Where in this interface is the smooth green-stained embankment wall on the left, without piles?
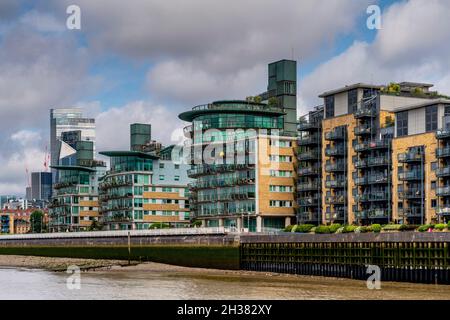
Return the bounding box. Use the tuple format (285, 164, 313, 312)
(0, 235, 239, 270)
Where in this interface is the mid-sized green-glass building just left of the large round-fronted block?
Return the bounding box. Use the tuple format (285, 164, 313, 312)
(100, 124, 190, 230)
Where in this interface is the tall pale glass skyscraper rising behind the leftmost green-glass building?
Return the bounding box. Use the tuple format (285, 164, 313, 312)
(50, 108, 95, 182)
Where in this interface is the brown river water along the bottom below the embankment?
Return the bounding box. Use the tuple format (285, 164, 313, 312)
(0, 268, 450, 300)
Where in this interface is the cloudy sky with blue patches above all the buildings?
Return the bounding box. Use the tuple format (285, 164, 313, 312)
(0, 0, 450, 195)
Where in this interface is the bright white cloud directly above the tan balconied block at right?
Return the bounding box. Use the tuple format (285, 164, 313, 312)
(300, 0, 450, 112)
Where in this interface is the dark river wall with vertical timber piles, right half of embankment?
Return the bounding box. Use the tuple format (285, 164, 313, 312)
(240, 232, 450, 284)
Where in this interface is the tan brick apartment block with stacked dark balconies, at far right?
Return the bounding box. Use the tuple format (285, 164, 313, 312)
(298, 82, 450, 224)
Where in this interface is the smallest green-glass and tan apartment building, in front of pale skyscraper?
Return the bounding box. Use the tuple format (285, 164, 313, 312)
(49, 141, 106, 232)
